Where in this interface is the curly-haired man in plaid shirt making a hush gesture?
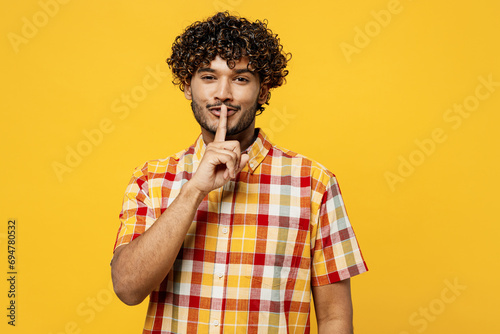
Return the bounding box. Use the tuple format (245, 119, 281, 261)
(112, 12, 367, 333)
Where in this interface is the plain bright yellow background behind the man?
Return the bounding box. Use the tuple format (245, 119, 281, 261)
(0, 0, 500, 334)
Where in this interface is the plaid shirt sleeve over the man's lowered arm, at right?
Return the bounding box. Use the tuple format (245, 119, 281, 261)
(311, 176, 368, 286)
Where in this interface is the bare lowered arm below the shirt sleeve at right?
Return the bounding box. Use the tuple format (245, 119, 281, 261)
(312, 279, 353, 334)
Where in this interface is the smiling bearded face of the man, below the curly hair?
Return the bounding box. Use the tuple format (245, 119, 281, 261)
(184, 56, 268, 137)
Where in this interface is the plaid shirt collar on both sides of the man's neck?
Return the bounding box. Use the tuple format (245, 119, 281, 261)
(194, 128, 273, 174)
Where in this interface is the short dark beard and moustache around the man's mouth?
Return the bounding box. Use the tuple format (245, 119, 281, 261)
(191, 99, 258, 136)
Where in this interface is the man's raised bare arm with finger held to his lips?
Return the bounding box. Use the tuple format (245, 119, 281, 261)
(111, 106, 248, 305)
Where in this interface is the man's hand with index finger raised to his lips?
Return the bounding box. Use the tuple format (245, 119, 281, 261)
(190, 104, 249, 194)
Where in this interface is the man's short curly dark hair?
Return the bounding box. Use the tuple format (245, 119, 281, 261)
(167, 11, 292, 114)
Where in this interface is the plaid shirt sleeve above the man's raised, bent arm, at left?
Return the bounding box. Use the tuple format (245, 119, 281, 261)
(113, 163, 155, 252)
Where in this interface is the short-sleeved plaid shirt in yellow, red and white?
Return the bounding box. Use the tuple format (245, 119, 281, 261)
(115, 130, 367, 333)
